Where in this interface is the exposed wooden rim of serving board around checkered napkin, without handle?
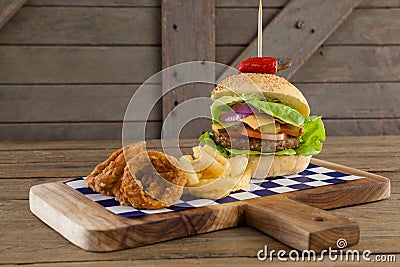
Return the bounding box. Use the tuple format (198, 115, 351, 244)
(29, 159, 390, 251)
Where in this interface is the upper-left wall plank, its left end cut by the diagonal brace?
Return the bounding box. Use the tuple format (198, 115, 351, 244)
(0, 6, 161, 46)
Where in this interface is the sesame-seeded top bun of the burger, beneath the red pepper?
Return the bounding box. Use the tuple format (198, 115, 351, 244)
(211, 73, 310, 116)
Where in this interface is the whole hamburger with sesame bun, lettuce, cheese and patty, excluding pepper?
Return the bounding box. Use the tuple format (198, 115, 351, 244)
(199, 73, 325, 179)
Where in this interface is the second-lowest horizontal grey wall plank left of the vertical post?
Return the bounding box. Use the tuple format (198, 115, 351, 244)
(0, 84, 162, 123)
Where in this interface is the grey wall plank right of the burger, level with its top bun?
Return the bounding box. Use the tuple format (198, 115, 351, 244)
(295, 83, 400, 119)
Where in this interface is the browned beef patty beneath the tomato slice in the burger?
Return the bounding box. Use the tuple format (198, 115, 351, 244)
(213, 131, 300, 153)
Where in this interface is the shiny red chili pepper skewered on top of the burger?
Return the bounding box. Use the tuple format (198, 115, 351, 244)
(238, 57, 292, 74)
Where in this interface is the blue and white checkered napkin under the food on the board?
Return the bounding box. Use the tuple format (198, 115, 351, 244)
(65, 164, 363, 217)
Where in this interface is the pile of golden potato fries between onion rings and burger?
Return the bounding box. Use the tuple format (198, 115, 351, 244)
(179, 145, 251, 199)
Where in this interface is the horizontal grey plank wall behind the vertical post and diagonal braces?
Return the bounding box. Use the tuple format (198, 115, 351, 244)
(0, 0, 400, 140)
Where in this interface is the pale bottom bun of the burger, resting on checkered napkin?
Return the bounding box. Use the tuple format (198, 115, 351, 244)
(249, 155, 311, 179)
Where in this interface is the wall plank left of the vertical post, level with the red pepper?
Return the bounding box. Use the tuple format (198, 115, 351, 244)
(0, 46, 161, 84)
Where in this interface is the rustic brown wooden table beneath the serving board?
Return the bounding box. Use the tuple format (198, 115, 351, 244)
(0, 136, 400, 266)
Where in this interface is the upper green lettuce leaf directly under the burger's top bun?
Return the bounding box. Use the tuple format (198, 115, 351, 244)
(211, 96, 305, 126)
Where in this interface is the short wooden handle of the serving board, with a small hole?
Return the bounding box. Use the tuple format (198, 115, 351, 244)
(244, 196, 360, 252)
